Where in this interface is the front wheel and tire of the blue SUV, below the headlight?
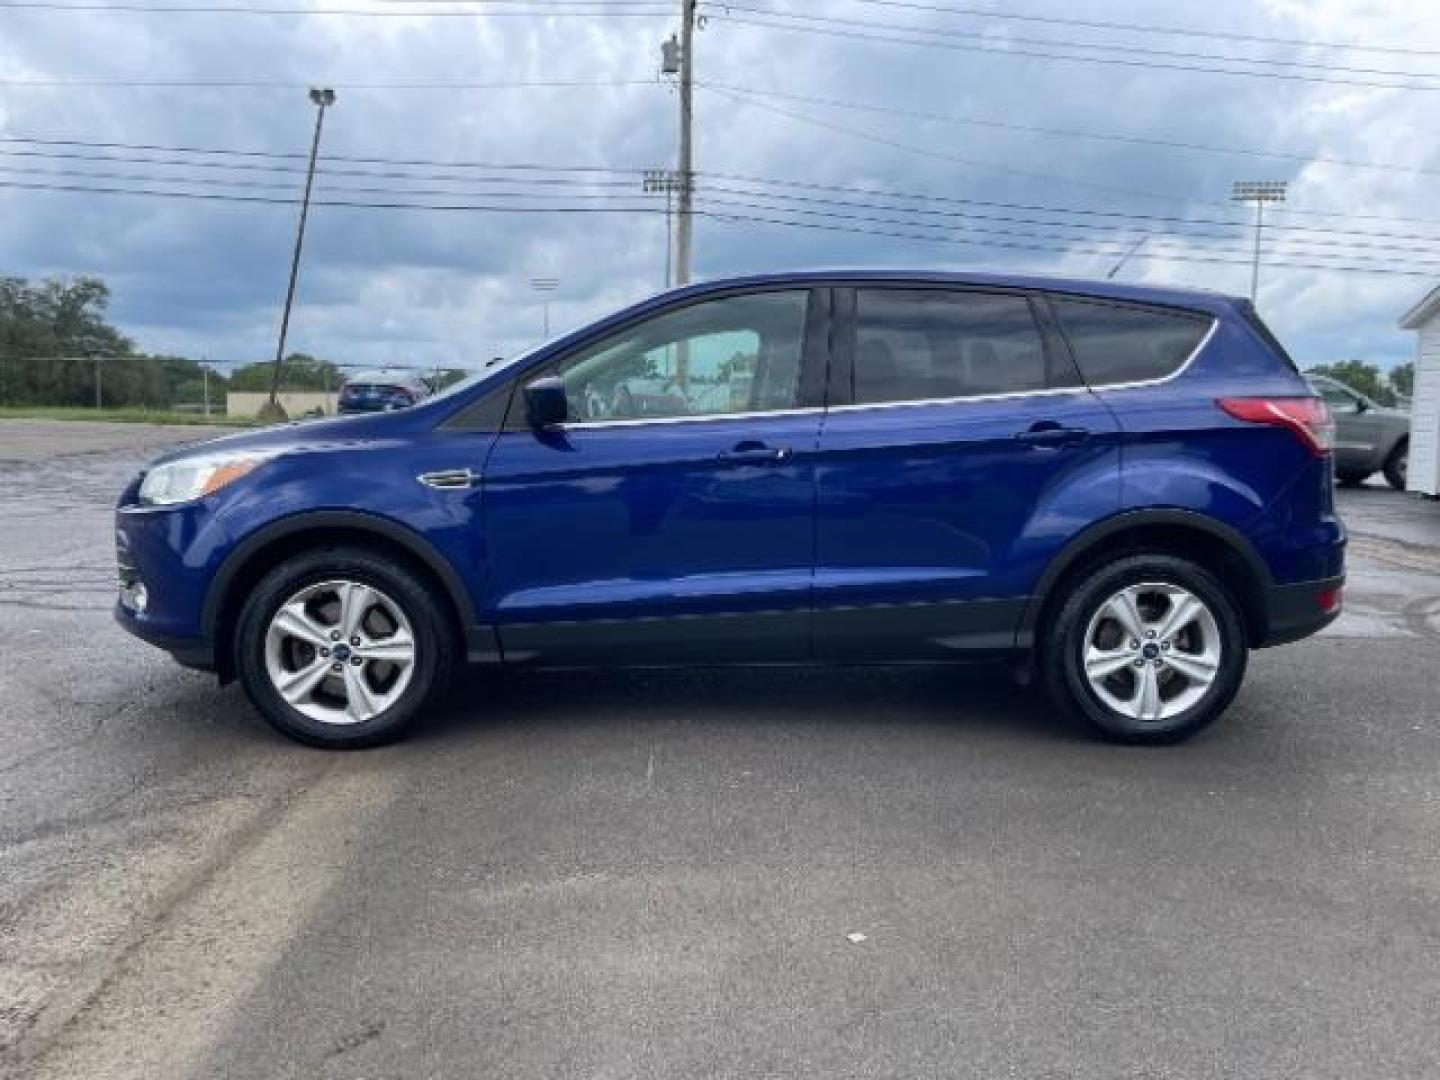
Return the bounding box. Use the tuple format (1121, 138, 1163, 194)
(235, 547, 454, 749)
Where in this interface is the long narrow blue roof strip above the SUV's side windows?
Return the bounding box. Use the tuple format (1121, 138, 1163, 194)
(662, 268, 1234, 311)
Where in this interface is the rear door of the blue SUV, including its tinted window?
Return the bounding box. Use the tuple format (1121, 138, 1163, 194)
(814, 285, 1119, 660)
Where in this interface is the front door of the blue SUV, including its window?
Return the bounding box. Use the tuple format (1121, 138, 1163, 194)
(482, 289, 828, 664)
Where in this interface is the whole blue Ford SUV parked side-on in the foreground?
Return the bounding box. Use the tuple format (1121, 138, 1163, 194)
(115, 272, 1345, 747)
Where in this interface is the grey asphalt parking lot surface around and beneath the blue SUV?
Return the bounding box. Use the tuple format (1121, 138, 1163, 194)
(0, 422, 1440, 1080)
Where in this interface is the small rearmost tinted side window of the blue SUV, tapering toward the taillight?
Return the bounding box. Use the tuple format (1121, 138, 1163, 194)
(1050, 297, 1211, 386)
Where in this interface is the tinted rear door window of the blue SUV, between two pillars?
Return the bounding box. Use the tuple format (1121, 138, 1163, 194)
(854, 289, 1074, 405)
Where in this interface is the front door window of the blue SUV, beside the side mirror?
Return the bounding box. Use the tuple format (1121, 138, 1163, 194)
(552, 289, 808, 423)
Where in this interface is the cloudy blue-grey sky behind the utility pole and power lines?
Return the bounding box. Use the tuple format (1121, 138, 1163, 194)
(0, 0, 1440, 366)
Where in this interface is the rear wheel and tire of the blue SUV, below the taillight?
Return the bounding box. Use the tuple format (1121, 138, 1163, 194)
(1041, 554, 1248, 744)
